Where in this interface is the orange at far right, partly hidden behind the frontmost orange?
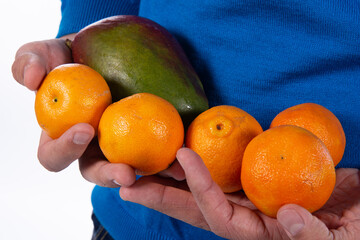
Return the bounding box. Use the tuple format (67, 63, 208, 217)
(270, 103, 346, 166)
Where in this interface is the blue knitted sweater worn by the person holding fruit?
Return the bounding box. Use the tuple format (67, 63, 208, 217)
(58, 0, 360, 239)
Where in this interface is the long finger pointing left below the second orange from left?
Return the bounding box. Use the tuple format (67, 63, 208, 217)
(120, 176, 210, 230)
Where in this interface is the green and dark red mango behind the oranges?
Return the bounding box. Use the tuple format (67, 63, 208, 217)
(71, 15, 209, 127)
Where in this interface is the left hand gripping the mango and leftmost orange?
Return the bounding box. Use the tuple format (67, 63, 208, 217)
(12, 38, 136, 187)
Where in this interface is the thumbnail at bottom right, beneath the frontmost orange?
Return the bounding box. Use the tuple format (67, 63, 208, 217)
(277, 210, 305, 236)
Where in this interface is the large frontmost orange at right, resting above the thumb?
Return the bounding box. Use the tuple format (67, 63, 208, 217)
(241, 125, 335, 217)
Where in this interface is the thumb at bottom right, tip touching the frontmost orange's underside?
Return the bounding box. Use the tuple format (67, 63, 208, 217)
(277, 204, 333, 240)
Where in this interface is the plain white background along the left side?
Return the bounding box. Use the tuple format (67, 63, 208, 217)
(0, 0, 93, 240)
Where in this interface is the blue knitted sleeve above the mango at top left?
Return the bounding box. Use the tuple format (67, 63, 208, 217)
(56, 0, 140, 37)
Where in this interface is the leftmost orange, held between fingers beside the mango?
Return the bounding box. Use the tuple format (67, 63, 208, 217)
(35, 64, 112, 139)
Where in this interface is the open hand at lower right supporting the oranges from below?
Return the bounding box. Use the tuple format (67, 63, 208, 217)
(120, 148, 360, 239)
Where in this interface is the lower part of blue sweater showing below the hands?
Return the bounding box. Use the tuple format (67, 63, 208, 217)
(92, 186, 222, 240)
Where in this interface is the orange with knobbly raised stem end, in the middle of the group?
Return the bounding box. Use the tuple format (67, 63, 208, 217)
(185, 105, 263, 193)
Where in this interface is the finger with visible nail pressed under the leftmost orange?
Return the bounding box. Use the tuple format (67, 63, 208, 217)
(38, 123, 95, 172)
